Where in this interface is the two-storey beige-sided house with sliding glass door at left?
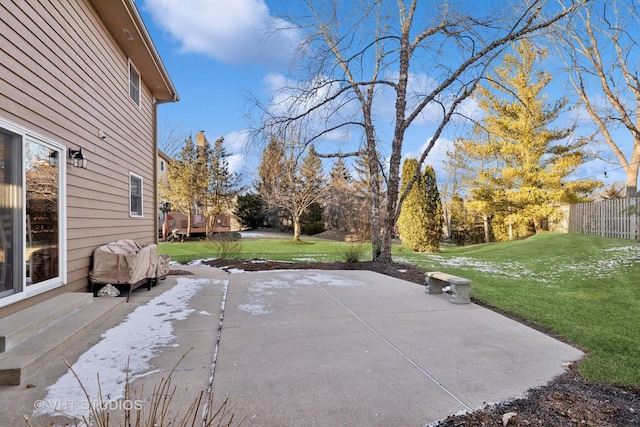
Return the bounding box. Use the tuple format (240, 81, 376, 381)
(0, 0, 178, 318)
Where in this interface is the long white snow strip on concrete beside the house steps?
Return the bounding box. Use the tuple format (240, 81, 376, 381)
(36, 277, 222, 418)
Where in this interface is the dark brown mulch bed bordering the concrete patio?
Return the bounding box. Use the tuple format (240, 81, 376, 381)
(170, 260, 640, 427)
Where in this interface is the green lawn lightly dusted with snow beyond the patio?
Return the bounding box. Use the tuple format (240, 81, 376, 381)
(160, 233, 640, 385)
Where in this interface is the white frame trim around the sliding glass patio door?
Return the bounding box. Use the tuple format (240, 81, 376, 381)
(0, 117, 67, 308)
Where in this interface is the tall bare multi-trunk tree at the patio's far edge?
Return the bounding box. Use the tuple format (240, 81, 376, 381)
(264, 0, 588, 262)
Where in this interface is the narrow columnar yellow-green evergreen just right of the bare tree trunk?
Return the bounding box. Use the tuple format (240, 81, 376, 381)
(398, 158, 444, 252)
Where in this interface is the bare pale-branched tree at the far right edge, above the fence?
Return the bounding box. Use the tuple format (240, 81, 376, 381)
(555, 0, 640, 197)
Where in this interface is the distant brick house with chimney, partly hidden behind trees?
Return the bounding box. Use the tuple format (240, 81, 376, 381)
(158, 131, 240, 238)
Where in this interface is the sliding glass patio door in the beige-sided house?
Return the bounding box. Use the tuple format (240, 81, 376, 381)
(0, 120, 65, 306)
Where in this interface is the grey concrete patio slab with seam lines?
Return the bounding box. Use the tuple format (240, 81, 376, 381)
(0, 266, 583, 426)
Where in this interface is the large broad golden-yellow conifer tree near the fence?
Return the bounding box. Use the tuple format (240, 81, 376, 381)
(457, 40, 597, 238)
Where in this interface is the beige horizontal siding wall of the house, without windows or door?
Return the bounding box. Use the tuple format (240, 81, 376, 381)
(0, 0, 156, 317)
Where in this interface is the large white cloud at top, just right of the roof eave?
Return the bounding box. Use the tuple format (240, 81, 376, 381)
(143, 0, 299, 65)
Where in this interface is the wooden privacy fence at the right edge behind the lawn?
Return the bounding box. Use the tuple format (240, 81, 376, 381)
(569, 197, 640, 240)
